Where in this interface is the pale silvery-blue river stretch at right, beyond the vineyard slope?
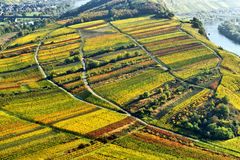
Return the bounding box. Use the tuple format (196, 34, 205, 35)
(205, 23, 240, 56)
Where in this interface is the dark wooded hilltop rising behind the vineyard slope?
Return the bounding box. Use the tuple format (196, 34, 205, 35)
(61, 0, 170, 20)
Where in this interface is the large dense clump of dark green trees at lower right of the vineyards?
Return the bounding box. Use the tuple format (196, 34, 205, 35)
(172, 96, 239, 140)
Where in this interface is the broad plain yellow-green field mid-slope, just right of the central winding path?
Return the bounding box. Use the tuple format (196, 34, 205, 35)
(94, 69, 174, 105)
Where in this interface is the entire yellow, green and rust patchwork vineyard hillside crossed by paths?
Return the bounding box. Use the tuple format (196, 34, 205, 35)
(0, 10, 240, 160)
